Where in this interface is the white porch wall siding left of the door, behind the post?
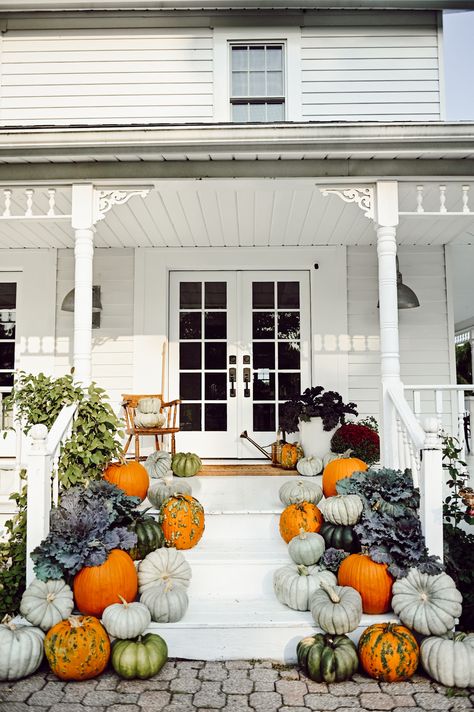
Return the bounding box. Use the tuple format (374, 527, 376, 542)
(56, 249, 134, 410)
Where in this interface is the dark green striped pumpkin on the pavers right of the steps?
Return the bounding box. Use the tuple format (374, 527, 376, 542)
(296, 633, 359, 682)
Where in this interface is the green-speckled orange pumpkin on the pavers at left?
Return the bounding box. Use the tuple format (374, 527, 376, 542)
(44, 616, 110, 680)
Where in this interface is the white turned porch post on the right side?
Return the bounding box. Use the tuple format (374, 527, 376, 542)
(376, 181, 402, 468)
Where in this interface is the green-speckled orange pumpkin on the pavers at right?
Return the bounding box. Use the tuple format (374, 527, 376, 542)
(359, 623, 420, 682)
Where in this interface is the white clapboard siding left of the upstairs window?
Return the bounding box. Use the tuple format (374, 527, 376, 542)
(0, 28, 213, 126)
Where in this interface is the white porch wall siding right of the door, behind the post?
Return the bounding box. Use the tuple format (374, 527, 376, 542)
(347, 246, 450, 417)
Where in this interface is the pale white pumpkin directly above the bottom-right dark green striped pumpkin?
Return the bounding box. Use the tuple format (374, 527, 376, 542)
(310, 582, 362, 635)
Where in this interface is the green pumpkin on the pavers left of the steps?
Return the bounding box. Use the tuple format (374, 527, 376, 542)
(111, 633, 168, 680)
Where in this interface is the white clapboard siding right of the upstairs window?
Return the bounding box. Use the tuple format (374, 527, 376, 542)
(301, 11, 440, 121)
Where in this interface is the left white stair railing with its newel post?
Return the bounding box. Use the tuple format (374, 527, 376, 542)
(26, 403, 77, 586)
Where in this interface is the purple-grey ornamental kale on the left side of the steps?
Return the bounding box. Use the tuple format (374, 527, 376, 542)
(31, 481, 140, 581)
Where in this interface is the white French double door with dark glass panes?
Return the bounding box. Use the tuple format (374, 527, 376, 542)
(169, 270, 311, 459)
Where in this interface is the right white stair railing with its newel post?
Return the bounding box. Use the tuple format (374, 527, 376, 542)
(383, 386, 443, 560)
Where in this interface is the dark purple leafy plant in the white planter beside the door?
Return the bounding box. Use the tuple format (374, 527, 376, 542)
(279, 386, 357, 433)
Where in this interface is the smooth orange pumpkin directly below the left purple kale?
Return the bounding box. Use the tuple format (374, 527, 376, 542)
(73, 549, 138, 616)
